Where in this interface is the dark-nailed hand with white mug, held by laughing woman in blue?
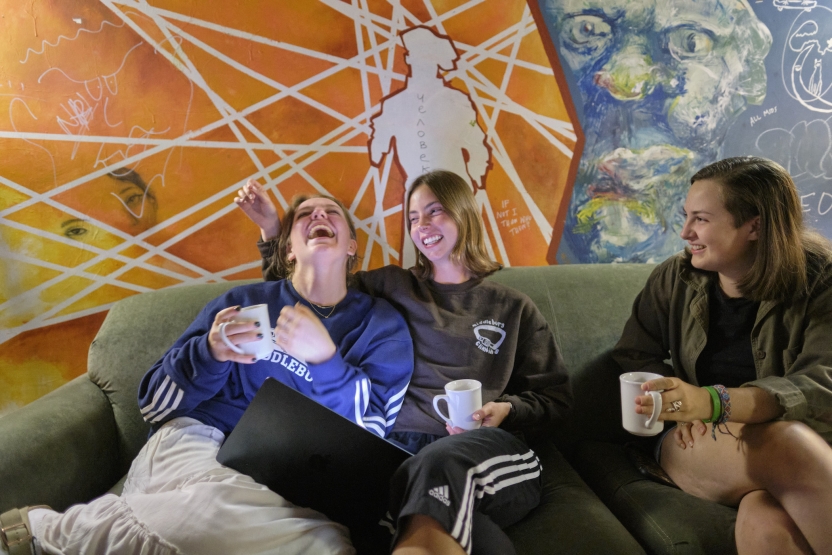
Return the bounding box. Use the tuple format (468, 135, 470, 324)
(208, 305, 272, 364)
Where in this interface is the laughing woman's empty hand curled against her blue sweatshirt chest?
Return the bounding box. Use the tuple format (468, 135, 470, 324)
(274, 303, 336, 364)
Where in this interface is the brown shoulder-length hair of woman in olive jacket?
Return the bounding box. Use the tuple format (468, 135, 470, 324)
(688, 156, 832, 301)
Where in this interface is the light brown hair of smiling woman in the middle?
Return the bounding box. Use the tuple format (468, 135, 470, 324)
(405, 170, 502, 279)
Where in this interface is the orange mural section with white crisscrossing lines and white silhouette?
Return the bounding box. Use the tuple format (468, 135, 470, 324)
(0, 0, 580, 414)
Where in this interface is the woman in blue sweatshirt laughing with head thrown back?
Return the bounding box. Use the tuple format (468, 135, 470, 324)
(0, 197, 413, 555)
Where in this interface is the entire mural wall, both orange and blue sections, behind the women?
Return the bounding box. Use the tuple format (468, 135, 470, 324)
(0, 0, 832, 414)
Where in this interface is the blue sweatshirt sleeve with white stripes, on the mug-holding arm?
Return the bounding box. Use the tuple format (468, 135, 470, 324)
(139, 297, 234, 425)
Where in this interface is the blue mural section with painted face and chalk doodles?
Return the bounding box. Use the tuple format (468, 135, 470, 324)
(540, 0, 832, 263)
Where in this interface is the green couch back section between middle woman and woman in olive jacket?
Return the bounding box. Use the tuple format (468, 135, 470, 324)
(490, 264, 655, 455)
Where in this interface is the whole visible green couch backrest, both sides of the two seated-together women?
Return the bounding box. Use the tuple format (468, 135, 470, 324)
(89, 264, 654, 472)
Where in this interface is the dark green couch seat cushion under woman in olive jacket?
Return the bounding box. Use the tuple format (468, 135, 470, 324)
(574, 441, 737, 555)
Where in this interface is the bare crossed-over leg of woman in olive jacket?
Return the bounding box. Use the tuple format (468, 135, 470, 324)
(662, 421, 832, 553)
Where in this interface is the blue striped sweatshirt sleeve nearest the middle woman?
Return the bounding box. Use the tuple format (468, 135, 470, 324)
(308, 299, 413, 437)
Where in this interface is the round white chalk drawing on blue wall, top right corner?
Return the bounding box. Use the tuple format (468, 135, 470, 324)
(782, 6, 832, 114)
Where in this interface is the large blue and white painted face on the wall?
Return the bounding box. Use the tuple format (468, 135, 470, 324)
(542, 0, 771, 262)
